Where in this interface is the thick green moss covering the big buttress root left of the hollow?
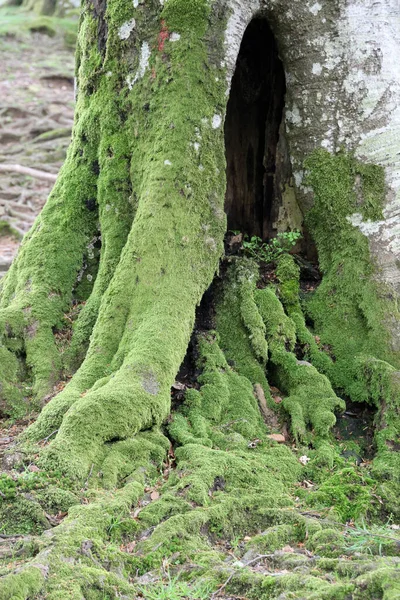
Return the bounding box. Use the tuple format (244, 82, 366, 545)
(23, 2, 225, 476)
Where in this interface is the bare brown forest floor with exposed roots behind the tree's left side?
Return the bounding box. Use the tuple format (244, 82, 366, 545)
(0, 8, 74, 276)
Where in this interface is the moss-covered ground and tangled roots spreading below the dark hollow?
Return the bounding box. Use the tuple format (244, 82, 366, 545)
(0, 255, 400, 600)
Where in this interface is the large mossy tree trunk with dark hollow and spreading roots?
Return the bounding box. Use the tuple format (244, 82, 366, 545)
(0, 0, 400, 598)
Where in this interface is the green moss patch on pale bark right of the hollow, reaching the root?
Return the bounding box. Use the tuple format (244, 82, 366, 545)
(306, 151, 400, 473)
